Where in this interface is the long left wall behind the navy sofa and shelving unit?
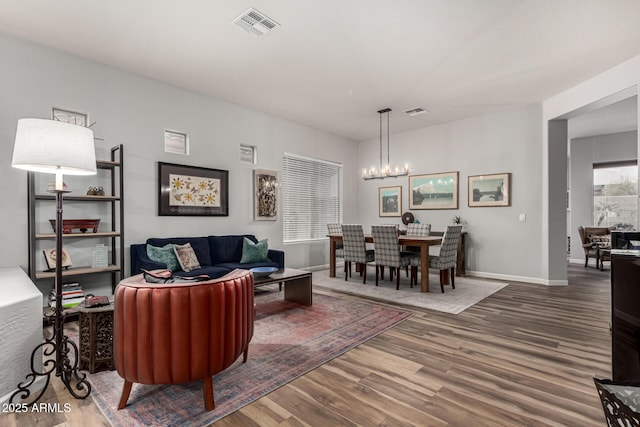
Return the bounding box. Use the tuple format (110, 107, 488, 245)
(0, 36, 358, 296)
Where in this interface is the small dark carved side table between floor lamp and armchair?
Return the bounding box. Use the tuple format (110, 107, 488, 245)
(74, 299, 115, 374)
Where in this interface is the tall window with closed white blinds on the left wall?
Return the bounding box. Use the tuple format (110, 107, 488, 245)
(281, 153, 342, 243)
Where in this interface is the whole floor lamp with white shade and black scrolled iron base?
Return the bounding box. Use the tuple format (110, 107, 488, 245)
(10, 119, 96, 403)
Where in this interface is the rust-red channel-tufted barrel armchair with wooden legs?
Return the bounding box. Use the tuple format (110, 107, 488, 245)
(113, 270, 255, 411)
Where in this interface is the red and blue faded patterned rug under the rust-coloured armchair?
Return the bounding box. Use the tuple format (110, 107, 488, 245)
(88, 290, 411, 427)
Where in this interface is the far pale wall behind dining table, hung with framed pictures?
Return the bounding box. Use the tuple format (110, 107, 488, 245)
(358, 106, 543, 282)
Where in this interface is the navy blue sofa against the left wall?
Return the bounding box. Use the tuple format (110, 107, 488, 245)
(130, 234, 284, 279)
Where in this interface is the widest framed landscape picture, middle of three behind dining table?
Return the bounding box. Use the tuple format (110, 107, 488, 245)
(409, 171, 458, 209)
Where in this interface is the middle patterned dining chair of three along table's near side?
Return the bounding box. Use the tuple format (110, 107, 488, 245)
(371, 225, 420, 289)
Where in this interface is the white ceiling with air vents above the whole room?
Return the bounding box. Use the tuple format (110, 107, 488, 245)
(0, 0, 640, 140)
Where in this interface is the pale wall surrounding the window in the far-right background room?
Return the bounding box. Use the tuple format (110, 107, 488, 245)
(568, 131, 638, 263)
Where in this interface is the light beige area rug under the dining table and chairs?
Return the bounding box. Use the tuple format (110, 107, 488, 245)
(313, 265, 508, 314)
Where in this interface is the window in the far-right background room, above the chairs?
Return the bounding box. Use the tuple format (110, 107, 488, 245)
(593, 161, 638, 230)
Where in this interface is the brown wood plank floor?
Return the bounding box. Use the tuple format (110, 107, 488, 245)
(0, 265, 611, 427)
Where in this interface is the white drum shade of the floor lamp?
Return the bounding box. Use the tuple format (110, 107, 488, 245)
(11, 119, 96, 175)
